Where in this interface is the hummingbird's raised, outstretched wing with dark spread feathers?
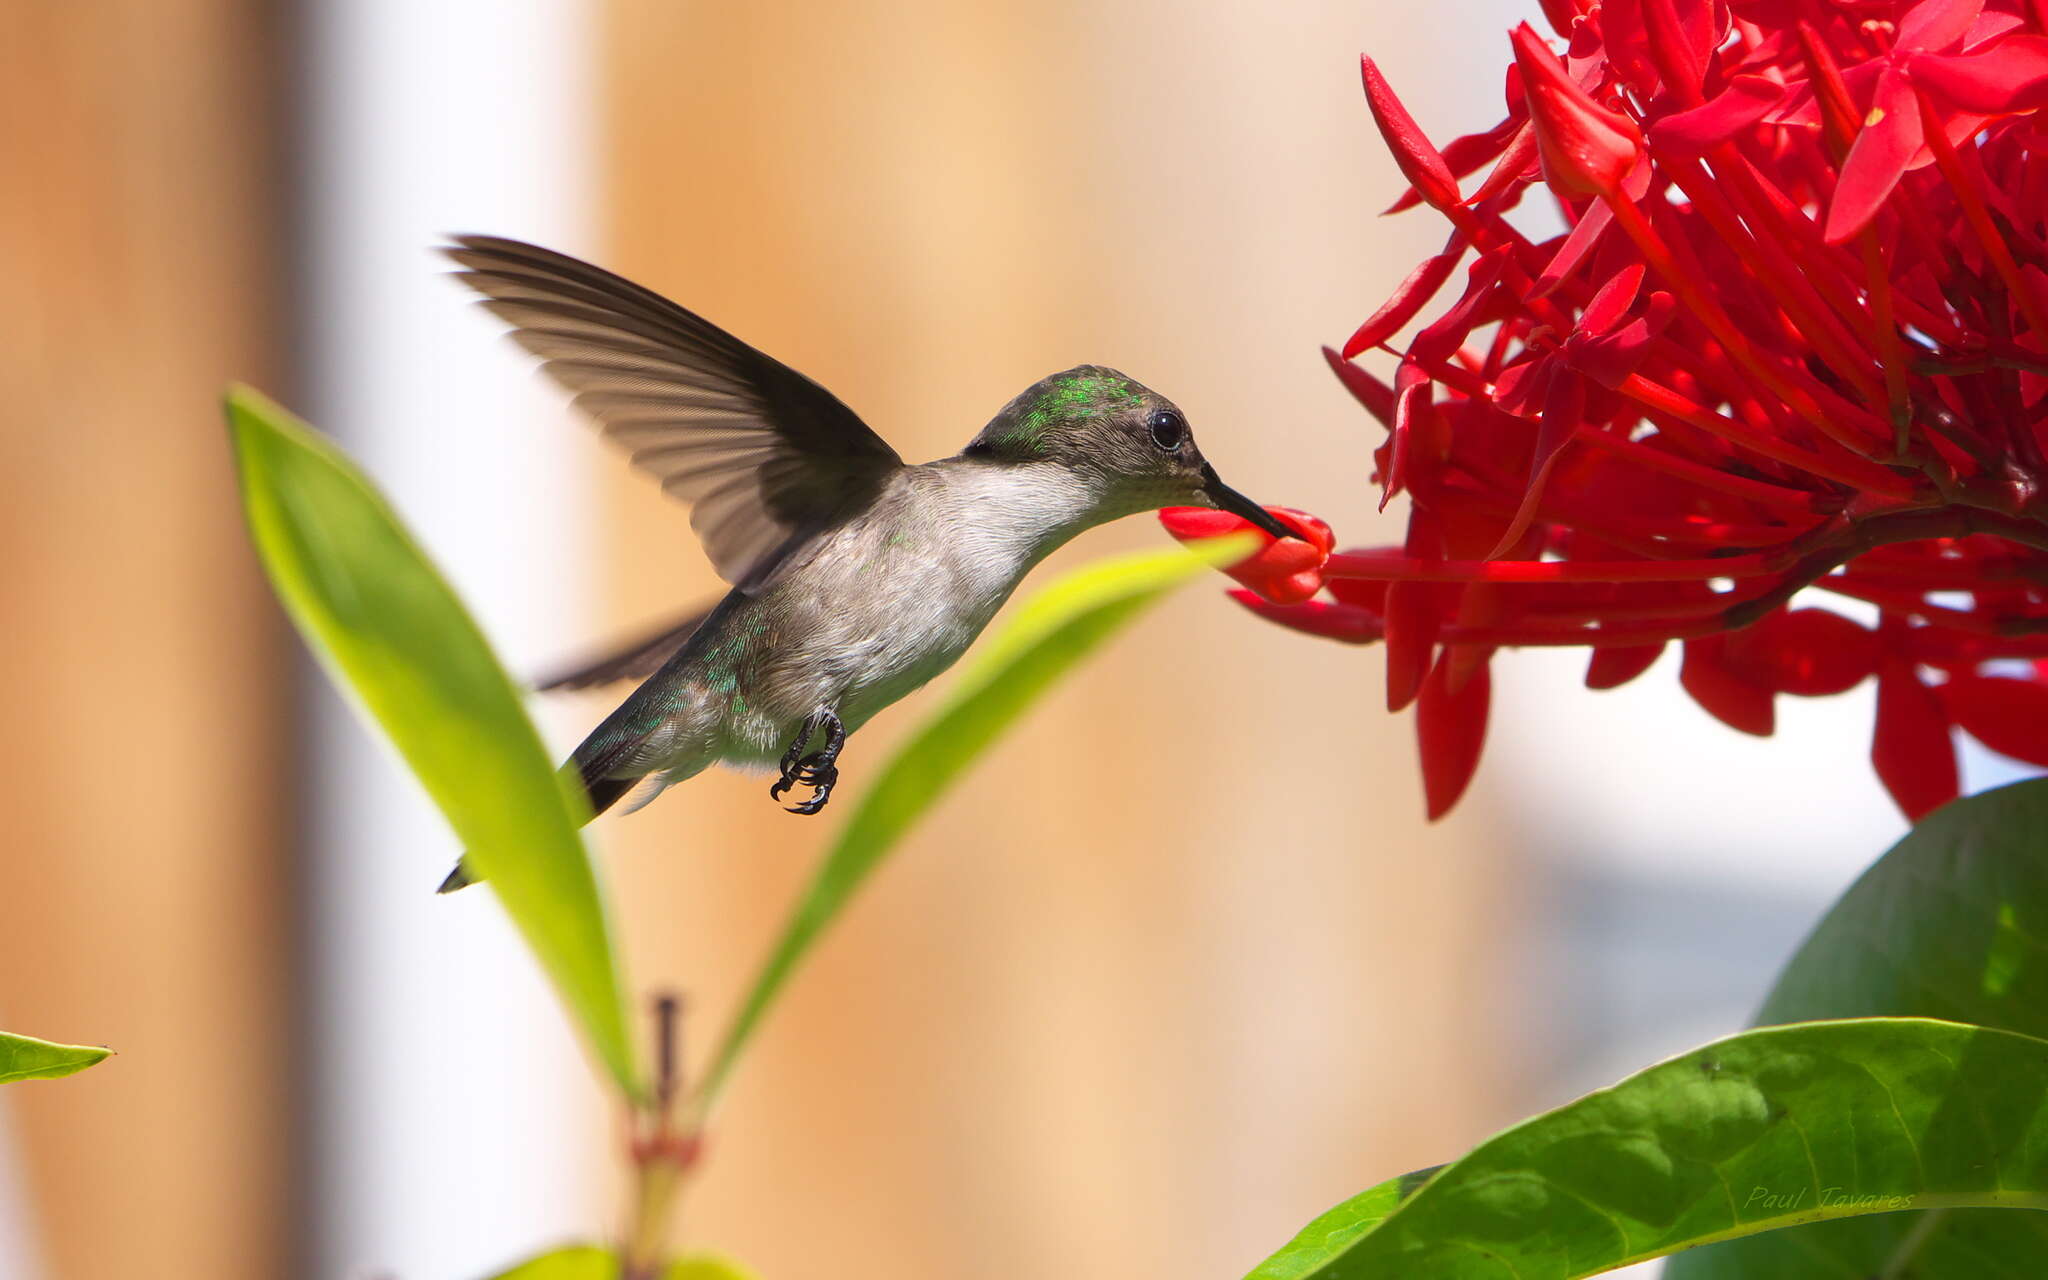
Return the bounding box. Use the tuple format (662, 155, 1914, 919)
(442, 236, 903, 592)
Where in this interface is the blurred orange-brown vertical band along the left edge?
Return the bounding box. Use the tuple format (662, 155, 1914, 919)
(0, 0, 295, 1280)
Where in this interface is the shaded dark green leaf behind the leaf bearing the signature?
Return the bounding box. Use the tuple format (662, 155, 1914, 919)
(1667, 778, 2048, 1280)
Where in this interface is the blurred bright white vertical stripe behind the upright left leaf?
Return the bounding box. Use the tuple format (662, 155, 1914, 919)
(301, 0, 606, 1280)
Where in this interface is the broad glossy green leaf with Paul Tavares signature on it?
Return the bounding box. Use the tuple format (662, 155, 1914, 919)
(1251, 1018, 2048, 1280)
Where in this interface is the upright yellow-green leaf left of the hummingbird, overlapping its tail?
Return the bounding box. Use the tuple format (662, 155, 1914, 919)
(227, 387, 641, 1098)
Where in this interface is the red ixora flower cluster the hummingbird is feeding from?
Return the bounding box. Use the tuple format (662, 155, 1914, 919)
(1165, 0, 2048, 817)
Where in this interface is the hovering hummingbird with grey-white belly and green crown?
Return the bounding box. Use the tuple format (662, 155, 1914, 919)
(440, 236, 1296, 893)
